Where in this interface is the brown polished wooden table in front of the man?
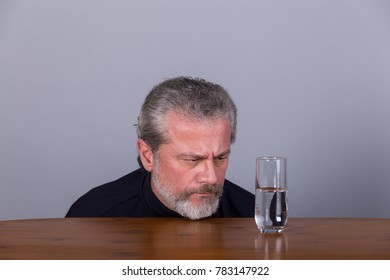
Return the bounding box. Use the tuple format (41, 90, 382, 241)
(0, 218, 390, 260)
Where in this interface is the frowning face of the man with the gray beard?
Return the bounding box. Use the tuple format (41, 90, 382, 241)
(151, 113, 231, 219)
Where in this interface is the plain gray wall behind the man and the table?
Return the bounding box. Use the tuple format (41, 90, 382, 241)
(0, 0, 390, 219)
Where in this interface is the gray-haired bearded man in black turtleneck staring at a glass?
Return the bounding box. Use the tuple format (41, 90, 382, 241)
(66, 77, 255, 220)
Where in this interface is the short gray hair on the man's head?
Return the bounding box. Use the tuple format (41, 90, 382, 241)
(137, 77, 237, 153)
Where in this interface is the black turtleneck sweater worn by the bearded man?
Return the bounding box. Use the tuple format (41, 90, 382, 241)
(66, 169, 255, 217)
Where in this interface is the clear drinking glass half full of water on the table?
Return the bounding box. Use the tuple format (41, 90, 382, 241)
(255, 156, 288, 233)
